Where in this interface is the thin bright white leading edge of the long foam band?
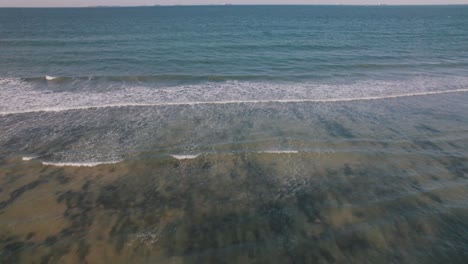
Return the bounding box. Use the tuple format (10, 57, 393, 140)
(0, 88, 468, 115)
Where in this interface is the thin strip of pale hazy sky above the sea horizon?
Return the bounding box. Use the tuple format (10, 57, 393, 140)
(0, 0, 468, 7)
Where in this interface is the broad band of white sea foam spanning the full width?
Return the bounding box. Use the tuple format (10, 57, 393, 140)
(0, 77, 468, 115)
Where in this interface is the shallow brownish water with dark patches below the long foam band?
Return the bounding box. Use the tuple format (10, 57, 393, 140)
(0, 93, 468, 263)
